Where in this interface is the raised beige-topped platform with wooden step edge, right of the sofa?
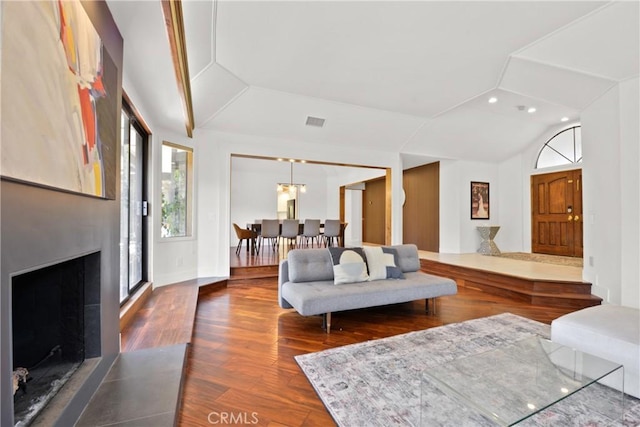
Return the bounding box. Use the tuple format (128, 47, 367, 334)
(420, 251, 602, 311)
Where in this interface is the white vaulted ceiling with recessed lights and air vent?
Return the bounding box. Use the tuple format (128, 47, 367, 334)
(107, 0, 640, 162)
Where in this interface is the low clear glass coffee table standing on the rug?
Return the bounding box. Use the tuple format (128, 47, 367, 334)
(420, 336, 624, 426)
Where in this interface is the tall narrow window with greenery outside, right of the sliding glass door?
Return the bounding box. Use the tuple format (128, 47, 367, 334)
(160, 142, 193, 237)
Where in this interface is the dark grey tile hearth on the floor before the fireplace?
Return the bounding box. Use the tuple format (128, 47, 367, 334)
(76, 343, 188, 427)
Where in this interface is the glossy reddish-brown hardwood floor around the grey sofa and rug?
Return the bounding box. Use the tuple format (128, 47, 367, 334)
(179, 248, 566, 427)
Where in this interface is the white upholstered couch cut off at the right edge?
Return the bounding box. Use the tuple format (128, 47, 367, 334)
(551, 304, 640, 398)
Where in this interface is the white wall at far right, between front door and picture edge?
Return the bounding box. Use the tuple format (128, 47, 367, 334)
(582, 78, 640, 307)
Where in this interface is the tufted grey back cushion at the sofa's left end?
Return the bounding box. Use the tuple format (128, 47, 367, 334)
(287, 249, 333, 283)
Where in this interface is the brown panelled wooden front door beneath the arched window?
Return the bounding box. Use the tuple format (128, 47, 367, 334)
(531, 169, 583, 257)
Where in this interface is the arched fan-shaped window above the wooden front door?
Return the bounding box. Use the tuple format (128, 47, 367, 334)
(536, 126, 582, 169)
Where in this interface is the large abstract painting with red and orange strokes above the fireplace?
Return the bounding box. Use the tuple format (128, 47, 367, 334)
(0, 0, 118, 199)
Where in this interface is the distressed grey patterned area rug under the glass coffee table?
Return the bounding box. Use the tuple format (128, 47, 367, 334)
(295, 313, 640, 427)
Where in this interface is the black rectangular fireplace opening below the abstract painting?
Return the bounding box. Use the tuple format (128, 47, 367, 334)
(11, 252, 100, 425)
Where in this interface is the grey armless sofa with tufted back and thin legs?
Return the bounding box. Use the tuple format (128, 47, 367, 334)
(278, 244, 458, 333)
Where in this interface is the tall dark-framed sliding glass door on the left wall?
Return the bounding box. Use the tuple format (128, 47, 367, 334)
(120, 100, 149, 304)
